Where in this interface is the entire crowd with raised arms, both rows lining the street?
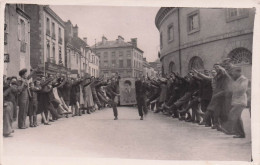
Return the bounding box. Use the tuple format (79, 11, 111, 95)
(3, 59, 251, 138)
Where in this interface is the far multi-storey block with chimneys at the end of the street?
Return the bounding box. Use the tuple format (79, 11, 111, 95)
(92, 36, 143, 77)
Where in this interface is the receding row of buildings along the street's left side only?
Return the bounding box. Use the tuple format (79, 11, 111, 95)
(4, 4, 99, 77)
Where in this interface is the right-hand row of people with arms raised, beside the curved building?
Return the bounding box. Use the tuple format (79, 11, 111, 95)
(141, 58, 251, 138)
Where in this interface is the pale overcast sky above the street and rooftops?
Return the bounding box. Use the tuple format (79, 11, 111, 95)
(50, 5, 159, 62)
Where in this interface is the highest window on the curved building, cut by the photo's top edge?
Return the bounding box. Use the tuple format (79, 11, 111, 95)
(226, 8, 249, 22)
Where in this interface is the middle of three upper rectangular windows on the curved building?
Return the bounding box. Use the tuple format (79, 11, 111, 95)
(188, 10, 199, 34)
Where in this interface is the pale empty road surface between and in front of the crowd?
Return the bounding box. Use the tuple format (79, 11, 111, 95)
(3, 107, 251, 161)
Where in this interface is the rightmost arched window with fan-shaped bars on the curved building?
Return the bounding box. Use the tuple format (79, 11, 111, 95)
(228, 48, 252, 65)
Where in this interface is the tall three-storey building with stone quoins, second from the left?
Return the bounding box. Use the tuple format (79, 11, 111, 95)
(24, 4, 67, 74)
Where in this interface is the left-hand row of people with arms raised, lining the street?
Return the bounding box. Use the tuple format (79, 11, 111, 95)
(3, 69, 119, 137)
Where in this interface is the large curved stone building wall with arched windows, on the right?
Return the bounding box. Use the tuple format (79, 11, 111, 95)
(155, 7, 255, 78)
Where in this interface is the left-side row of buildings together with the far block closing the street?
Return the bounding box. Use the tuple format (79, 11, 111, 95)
(4, 4, 158, 77)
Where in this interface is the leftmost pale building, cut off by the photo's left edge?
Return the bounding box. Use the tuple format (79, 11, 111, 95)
(4, 4, 31, 76)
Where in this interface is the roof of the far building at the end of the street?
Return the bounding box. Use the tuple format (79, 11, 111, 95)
(92, 40, 143, 53)
